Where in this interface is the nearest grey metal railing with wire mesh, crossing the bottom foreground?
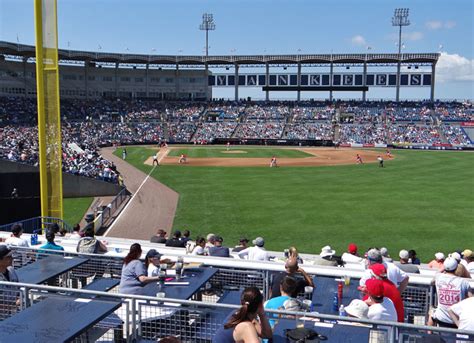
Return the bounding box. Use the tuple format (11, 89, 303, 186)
(0, 282, 474, 342)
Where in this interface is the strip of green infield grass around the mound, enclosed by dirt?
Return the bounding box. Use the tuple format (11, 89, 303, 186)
(168, 146, 313, 158)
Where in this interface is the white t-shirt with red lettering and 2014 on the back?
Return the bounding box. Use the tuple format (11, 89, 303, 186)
(433, 273, 469, 324)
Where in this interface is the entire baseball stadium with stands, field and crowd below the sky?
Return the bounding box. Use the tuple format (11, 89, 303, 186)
(0, 1, 474, 342)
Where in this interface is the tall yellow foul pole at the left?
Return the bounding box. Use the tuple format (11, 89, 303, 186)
(34, 0, 63, 219)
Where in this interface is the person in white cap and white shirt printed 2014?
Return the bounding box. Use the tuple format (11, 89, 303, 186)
(428, 257, 469, 328)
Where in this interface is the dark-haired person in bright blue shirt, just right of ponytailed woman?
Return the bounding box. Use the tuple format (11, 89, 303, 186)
(264, 276, 303, 328)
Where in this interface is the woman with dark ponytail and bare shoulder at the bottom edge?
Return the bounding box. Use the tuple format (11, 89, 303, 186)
(212, 287, 272, 343)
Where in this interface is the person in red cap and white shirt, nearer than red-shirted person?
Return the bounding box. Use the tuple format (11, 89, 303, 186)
(365, 279, 398, 322)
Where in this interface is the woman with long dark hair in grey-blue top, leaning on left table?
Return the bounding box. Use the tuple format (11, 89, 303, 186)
(120, 243, 160, 294)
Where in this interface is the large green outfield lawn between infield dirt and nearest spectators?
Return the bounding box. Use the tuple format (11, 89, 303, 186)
(118, 147, 474, 261)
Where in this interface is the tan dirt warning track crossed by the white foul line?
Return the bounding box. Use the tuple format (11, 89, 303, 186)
(101, 147, 179, 240)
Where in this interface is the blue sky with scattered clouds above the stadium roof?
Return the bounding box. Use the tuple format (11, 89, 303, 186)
(0, 0, 474, 99)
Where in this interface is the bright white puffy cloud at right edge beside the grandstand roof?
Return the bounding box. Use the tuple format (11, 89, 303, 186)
(436, 52, 474, 82)
